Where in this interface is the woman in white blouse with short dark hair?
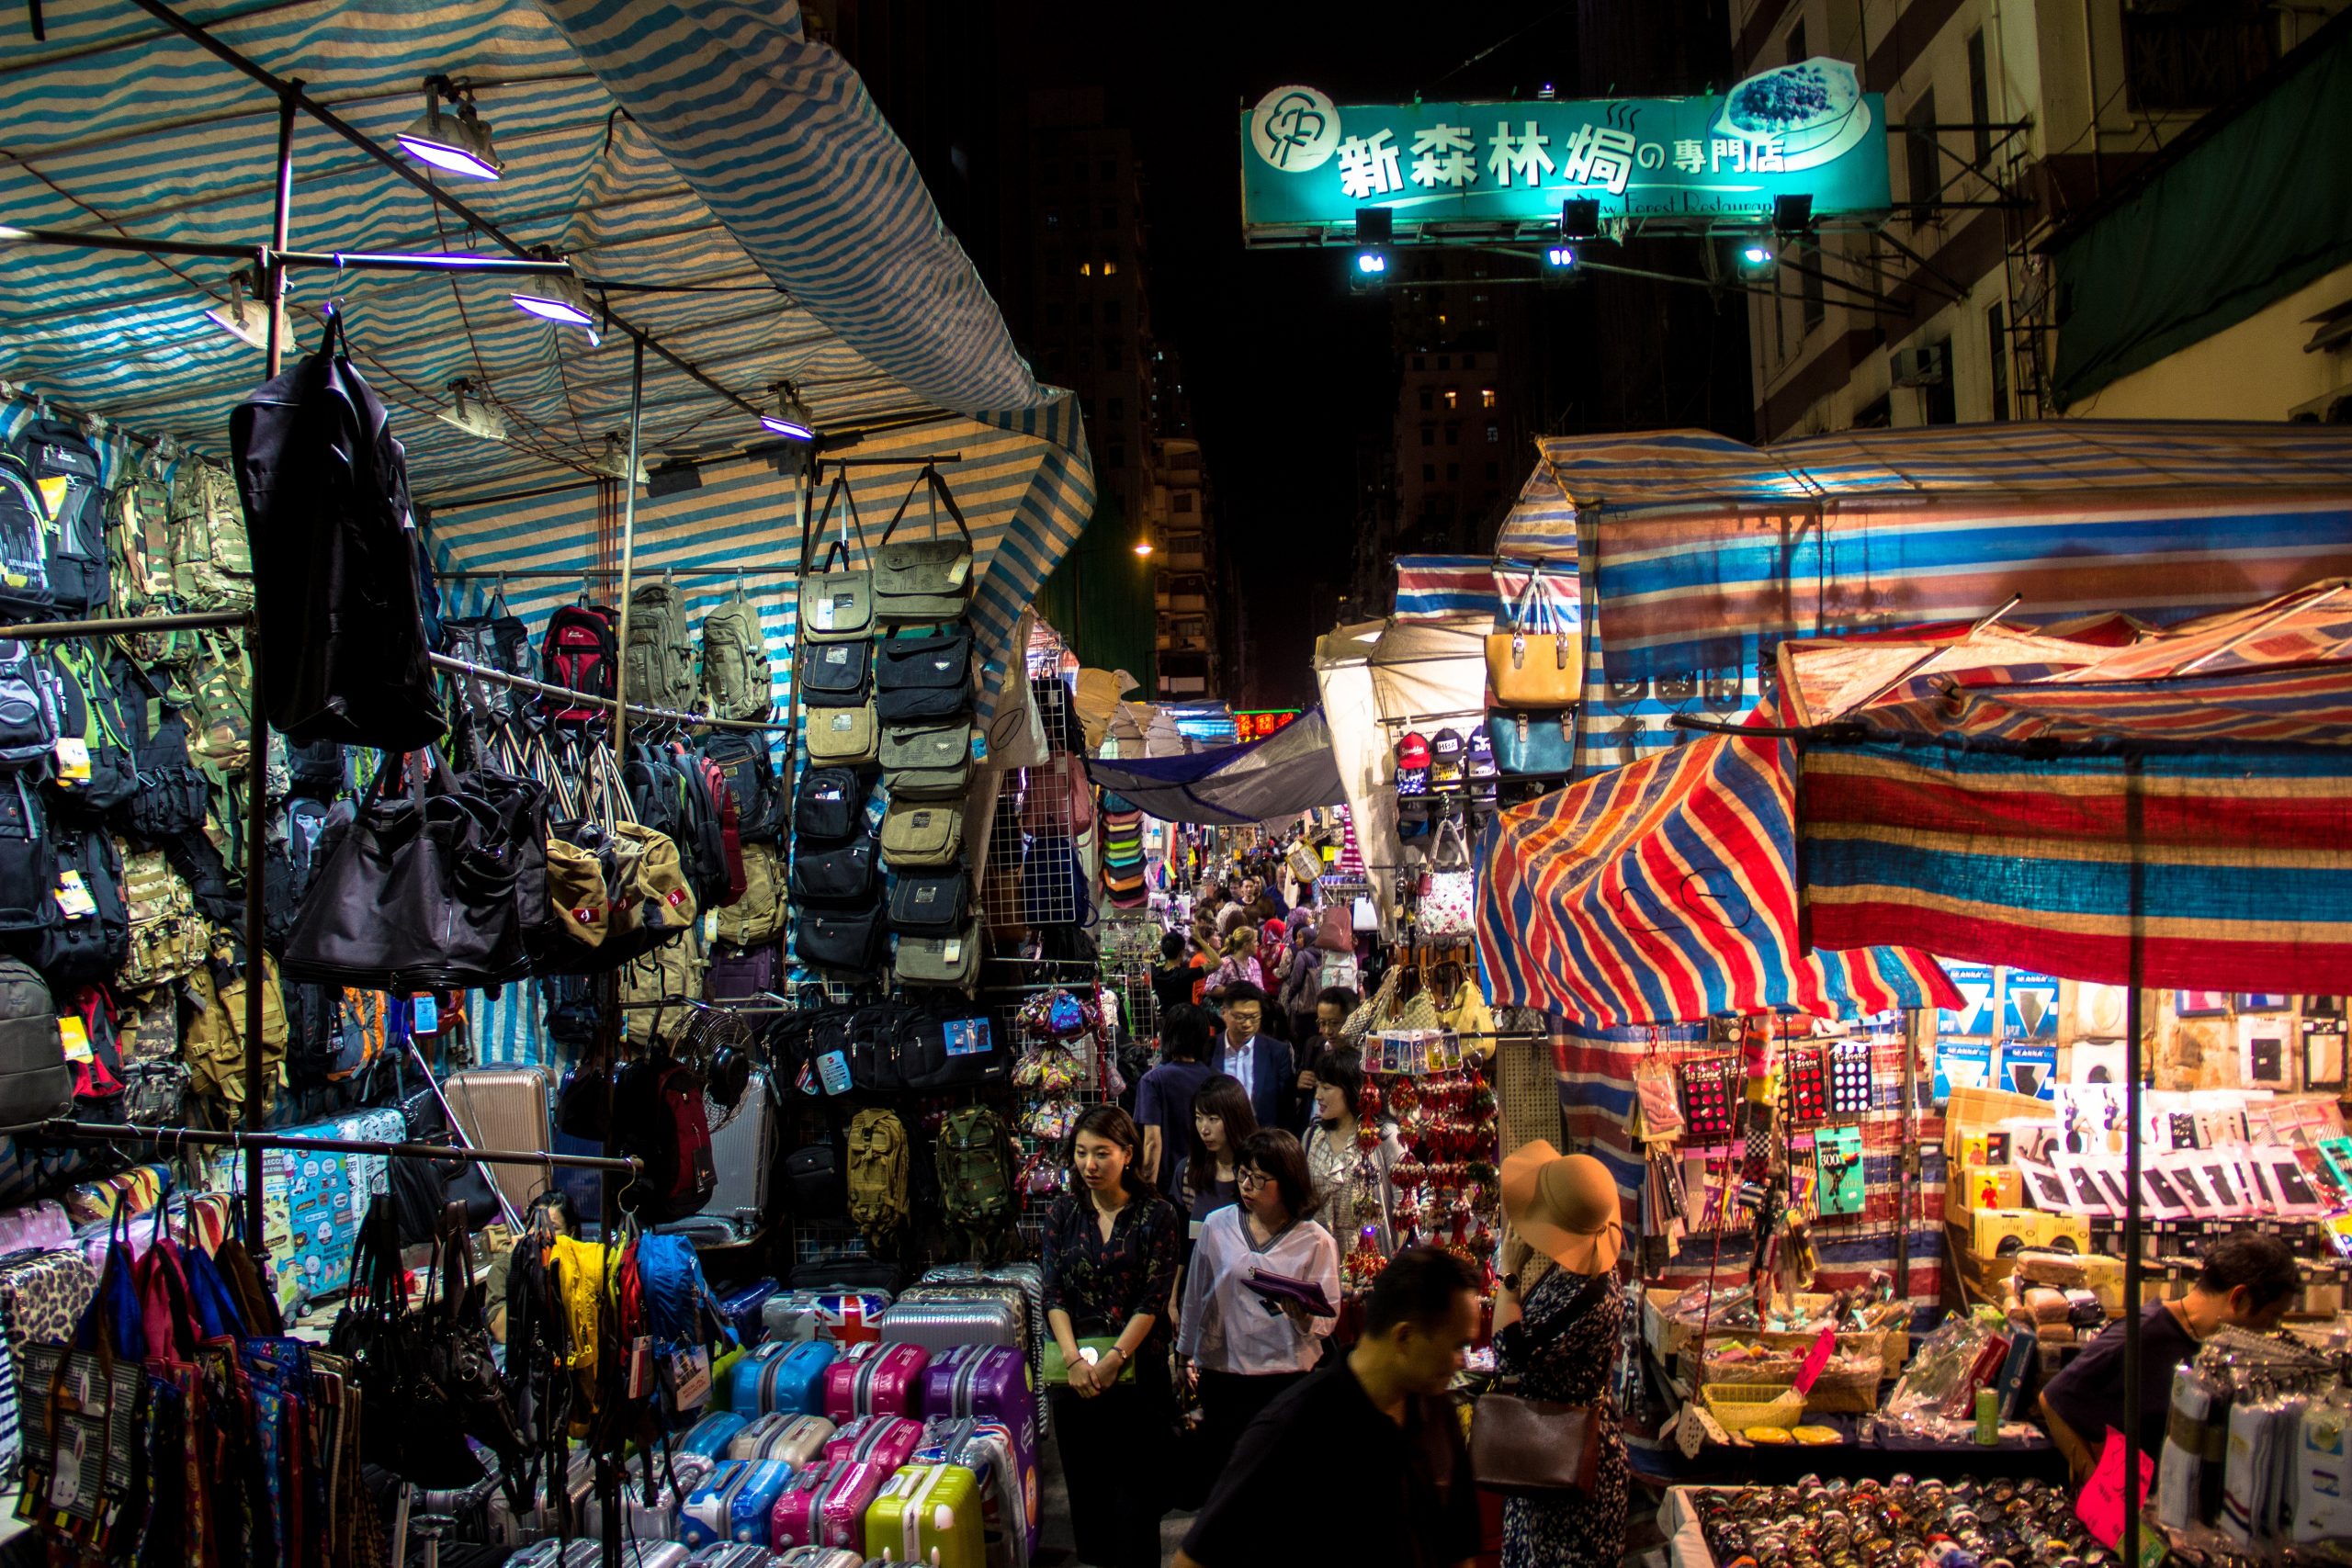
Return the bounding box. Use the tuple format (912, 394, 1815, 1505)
(1176, 1128, 1339, 1474)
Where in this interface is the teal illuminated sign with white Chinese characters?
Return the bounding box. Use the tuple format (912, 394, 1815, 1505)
(1242, 59, 1894, 244)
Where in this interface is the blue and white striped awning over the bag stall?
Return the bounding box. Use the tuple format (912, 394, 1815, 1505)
(0, 0, 1093, 705)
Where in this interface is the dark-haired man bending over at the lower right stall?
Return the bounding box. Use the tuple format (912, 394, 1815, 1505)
(2041, 1229, 2302, 1479)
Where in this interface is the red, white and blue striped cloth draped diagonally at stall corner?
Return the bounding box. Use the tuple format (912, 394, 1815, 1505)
(1477, 736, 1959, 1025)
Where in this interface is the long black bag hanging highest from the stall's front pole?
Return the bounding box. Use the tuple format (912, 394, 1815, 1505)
(228, 310, 449, 752)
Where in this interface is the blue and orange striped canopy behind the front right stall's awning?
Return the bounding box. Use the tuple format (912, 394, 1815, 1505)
(1496, 421, 2352, 769)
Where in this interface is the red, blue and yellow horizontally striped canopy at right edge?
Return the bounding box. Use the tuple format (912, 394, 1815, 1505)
(1802, 583, 2352, 995)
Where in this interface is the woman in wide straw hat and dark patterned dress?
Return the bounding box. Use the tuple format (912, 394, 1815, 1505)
(1494, 1138, 1628, 1568)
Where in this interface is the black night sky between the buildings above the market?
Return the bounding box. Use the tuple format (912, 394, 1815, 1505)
(1004, 0, 1576, 705)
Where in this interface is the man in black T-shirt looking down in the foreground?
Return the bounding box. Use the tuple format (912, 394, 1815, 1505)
(1176, 1246, 1479, 1568)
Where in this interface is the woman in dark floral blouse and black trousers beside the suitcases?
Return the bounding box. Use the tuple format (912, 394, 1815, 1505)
(1045, 1105, 1183, 1568)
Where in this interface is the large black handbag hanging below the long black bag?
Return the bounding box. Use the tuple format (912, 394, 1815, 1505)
(282, 752, 546, 992)
